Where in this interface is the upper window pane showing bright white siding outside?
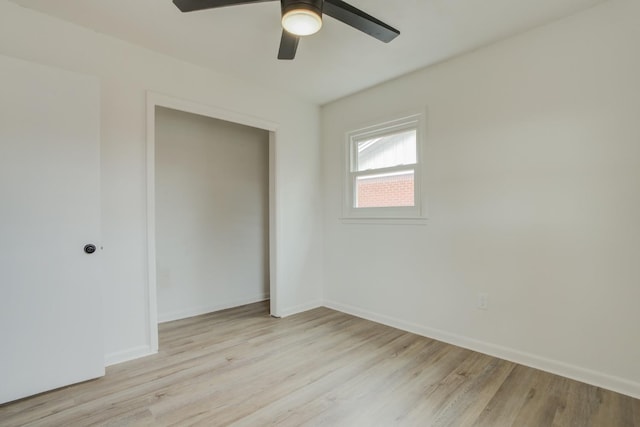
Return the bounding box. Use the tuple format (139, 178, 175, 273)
(355, 129, 416, 171)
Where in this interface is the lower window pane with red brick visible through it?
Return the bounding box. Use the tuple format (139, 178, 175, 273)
(355, 170, 415, 208)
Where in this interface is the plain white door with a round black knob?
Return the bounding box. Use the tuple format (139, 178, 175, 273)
(0, 56, 104, 403)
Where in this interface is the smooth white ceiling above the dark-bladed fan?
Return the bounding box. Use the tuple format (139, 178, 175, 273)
(12, 0, 604, 104)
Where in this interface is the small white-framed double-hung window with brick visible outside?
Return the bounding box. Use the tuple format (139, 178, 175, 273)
(344, 114, 424, 219)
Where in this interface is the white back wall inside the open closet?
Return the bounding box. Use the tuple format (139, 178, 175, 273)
(155, 107, 269, 321)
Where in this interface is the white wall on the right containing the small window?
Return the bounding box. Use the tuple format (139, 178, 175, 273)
(322, 0, 640, 396)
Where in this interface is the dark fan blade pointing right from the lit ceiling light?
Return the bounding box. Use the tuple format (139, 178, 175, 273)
(323, 0, 400, 43)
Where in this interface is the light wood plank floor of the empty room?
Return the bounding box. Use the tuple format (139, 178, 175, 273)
(0, 303, 640, 427)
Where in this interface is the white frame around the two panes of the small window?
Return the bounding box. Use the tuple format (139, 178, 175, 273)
(342, 112, 427, 224)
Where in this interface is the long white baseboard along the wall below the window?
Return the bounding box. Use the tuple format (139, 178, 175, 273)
(323, 300, 640, 399)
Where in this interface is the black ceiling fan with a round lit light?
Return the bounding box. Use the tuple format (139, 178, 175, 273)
(173, 0, 400, 59)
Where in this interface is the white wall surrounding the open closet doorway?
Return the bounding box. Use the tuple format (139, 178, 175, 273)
(0, 0, 322, 363)
